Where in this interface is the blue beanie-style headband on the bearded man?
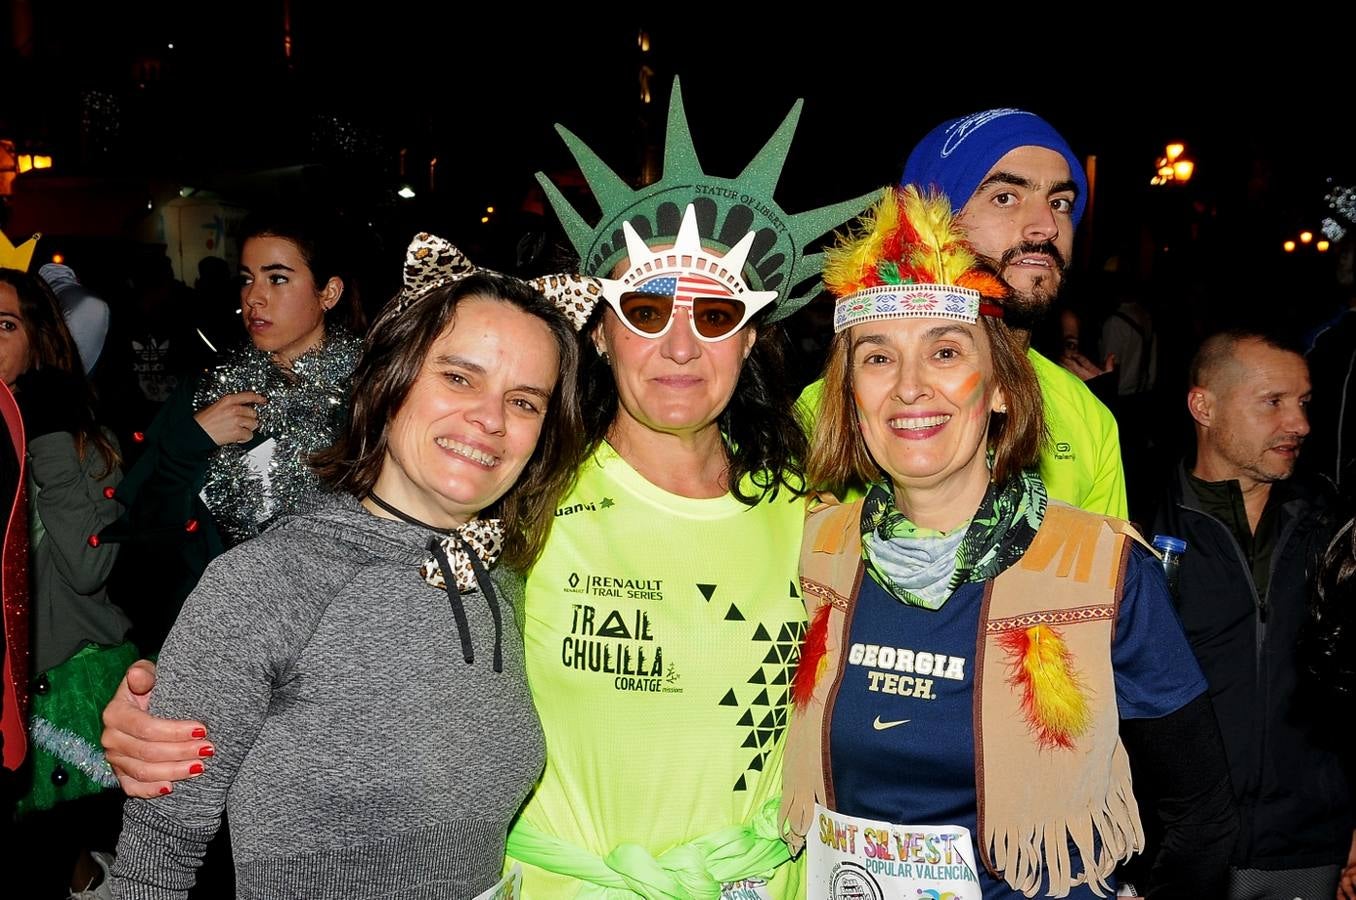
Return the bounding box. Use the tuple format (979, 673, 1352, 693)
(899, 110, 1088, 228)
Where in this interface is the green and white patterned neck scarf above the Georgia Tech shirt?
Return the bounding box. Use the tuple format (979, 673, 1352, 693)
(861, 469, 1045, 610)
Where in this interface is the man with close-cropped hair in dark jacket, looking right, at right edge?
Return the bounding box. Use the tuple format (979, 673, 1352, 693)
(1154, 332, 1356, 900)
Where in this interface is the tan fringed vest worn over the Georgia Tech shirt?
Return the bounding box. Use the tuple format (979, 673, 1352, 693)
(782, 499, 1143, 897)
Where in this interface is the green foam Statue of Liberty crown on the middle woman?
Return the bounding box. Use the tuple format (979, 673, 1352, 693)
(537, 79, 872, 324)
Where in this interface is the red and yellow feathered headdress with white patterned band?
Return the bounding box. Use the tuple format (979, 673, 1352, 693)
(824, 184, 1008, 332)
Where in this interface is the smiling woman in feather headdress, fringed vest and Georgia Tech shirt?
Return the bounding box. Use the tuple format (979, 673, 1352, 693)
(782, 186, 1235, 900)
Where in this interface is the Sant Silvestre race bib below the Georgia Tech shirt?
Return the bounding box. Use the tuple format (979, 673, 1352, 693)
(805, 804, 983, 900)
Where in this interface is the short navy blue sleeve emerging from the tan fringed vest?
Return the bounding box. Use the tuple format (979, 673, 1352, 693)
(1111, 545, 1205, 718)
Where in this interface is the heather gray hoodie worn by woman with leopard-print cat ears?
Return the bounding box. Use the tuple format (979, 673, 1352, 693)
(113, 496, 545, 900)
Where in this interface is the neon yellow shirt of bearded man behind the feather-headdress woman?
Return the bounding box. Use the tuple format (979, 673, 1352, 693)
(796, 350, 1130, 519)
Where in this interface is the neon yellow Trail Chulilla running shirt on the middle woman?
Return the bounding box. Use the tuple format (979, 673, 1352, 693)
(510, 443, 805, 899)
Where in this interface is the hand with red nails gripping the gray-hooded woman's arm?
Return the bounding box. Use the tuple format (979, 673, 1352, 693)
(102, 660, 214, 797)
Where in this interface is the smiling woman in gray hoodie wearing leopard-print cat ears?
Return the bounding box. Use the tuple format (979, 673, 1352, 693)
(113, 234, 582, 897)
